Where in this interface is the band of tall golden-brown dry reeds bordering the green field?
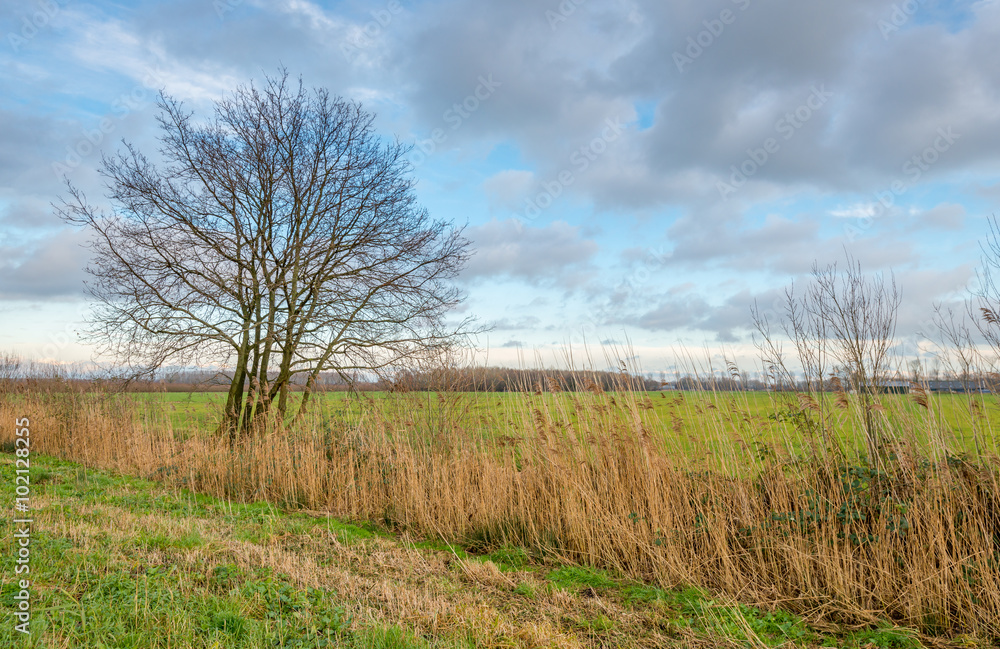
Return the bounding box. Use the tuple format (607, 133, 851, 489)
(0, 384, 1000, 637)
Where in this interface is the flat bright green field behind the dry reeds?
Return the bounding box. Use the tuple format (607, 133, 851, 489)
(145, 391, 1000, 460)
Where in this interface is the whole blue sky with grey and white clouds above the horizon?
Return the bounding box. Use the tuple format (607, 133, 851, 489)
(0, 0, 1000, 372)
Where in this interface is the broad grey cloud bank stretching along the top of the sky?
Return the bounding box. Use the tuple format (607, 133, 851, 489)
(17, 0, 1000, 218)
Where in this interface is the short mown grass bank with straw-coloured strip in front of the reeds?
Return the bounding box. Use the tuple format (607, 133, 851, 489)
(0, 455, 936, 649)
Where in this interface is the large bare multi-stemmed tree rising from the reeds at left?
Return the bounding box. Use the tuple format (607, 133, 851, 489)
(61, 71, 469, 433)
